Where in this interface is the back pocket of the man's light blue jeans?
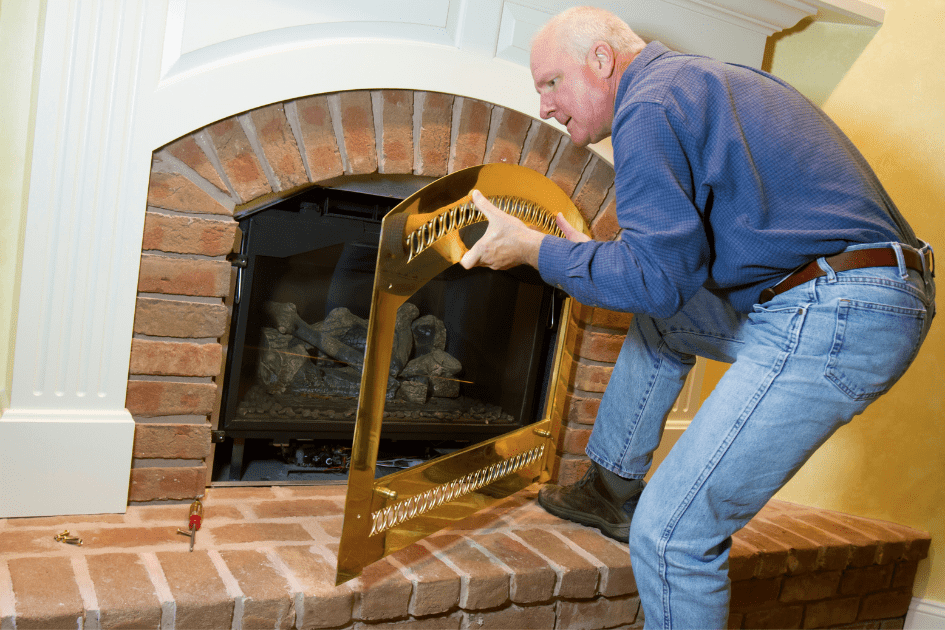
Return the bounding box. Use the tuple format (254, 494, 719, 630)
(824, 299, 926, 400)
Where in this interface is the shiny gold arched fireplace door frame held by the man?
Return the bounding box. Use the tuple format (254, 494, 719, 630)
(336, 164, 587, 584)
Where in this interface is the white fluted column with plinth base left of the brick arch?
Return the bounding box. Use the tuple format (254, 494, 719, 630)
(0, 0, 151, 516)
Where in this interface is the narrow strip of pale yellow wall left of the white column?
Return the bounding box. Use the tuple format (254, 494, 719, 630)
(0, 0, 45, 409)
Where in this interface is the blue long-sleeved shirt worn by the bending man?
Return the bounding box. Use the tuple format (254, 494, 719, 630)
(539, 42, 918, 317)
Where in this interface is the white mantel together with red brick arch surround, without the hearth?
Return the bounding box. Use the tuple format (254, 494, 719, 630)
(0, 0, 882, 516)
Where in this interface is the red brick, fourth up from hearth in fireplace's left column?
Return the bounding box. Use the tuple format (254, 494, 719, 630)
(129, 339, 223, 376)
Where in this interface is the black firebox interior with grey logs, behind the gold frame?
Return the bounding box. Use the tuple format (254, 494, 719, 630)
(213, 188, 561, 483)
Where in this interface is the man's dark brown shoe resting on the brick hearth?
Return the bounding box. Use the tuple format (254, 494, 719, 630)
(538, 462, 646, 542)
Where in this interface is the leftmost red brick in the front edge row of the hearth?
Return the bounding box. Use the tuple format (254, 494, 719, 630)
(7, 557, 85, 630)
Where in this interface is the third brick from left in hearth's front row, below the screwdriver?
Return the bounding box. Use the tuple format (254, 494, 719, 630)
(157, 549, 233, 628)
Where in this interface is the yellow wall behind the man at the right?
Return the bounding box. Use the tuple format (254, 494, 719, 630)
(703, 0, 945, 602)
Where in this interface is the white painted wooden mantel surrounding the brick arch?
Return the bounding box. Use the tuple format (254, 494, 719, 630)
(0, 0, 883, 518)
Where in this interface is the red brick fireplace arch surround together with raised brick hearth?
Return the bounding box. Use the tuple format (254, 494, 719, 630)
(0, 90, 930, 630)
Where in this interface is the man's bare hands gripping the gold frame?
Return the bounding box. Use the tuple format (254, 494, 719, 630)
(460, 190, 590, 269)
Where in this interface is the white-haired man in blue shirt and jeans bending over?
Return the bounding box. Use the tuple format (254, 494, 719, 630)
(462, 8, 934, 628)
